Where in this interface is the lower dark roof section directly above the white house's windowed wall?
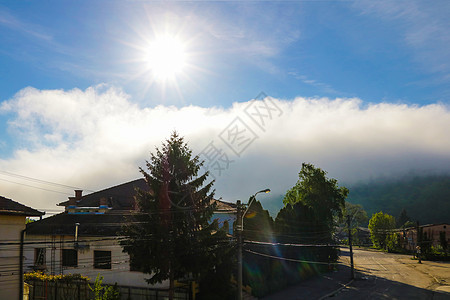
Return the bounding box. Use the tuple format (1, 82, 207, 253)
(27, 211, 127, 237)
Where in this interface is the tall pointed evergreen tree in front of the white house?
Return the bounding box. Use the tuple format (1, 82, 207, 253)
(122, 132, 225, 299)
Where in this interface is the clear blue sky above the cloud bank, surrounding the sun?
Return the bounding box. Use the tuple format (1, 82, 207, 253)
(0, 1, 450, 107)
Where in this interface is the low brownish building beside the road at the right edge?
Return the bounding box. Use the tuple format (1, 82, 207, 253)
(399, 223, 450, 251)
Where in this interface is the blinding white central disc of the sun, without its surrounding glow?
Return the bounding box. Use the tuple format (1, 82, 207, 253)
(148, 36, 186, 81)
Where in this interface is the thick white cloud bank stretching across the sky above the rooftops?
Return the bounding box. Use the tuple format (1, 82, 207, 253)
(0, 86, 450, 214)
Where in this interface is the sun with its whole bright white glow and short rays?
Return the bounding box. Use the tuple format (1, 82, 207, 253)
(116, 14, 208, 103)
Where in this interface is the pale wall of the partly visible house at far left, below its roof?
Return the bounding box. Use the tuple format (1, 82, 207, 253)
(0, 215, 25, 300)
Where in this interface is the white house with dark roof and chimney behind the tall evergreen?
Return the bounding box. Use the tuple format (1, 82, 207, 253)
(25, 179, 235, 289)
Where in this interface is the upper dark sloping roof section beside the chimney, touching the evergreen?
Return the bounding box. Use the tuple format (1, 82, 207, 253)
(58, 178, 149, 210)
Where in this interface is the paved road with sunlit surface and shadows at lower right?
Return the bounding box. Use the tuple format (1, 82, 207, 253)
(333, 249, 450, 300)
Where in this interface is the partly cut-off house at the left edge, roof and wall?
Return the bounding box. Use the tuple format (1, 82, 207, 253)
(0, 196, 44, 299)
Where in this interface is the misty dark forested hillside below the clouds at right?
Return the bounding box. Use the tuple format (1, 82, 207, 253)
(347, 175, 450, 224)
